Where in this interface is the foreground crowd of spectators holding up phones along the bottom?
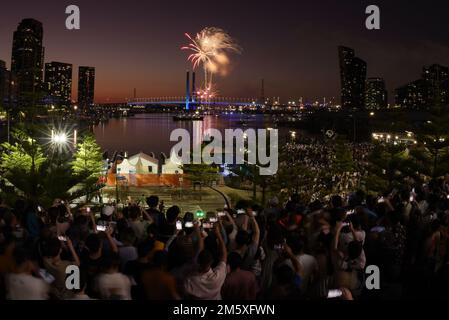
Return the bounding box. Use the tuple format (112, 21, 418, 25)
(0, 177, 449, 300)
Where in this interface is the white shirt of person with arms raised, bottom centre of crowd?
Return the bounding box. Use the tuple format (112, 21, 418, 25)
(184, 261, 226, 300)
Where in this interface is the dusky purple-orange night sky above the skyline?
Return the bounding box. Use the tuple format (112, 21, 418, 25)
(0, 0, 449, 102)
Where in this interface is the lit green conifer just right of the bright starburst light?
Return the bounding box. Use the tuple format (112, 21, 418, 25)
(72, 135, 103, 202)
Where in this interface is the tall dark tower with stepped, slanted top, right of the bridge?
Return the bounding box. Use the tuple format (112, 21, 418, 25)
(338, 46, 366, 109)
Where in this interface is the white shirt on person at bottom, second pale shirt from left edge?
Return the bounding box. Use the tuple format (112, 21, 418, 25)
(97, 272, 131, 300)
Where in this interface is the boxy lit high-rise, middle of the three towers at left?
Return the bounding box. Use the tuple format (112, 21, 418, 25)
(45, 62, 72, 107)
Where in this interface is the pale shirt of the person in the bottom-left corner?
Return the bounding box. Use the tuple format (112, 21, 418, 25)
(6, 273, 50, 300)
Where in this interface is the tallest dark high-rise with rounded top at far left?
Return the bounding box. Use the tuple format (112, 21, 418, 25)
(11, 19, 44, 105)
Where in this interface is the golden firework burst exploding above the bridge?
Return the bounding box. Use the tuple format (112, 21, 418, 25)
(181, 28, 241, 90)
